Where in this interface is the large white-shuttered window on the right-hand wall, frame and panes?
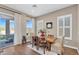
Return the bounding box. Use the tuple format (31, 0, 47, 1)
(57, 14, 72, 40)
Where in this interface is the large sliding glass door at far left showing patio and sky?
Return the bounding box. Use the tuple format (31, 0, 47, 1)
(0, 16, 14, 48)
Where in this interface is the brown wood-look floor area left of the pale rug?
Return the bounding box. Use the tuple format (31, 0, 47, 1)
(1, 45, 39, 55)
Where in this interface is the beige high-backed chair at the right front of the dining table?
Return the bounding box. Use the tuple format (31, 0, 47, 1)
(51, 37, 64, 55)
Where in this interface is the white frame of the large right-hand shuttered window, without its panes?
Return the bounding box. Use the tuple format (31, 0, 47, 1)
(57, 14, 72, 40)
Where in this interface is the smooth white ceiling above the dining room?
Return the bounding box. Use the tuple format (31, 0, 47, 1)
(5, 4, 72, 17)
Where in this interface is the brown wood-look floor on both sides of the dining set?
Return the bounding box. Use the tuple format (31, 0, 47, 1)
(1, 44, 78, 55)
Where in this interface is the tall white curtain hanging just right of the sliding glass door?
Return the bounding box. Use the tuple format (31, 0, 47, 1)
(14, 14, 22, 45)
